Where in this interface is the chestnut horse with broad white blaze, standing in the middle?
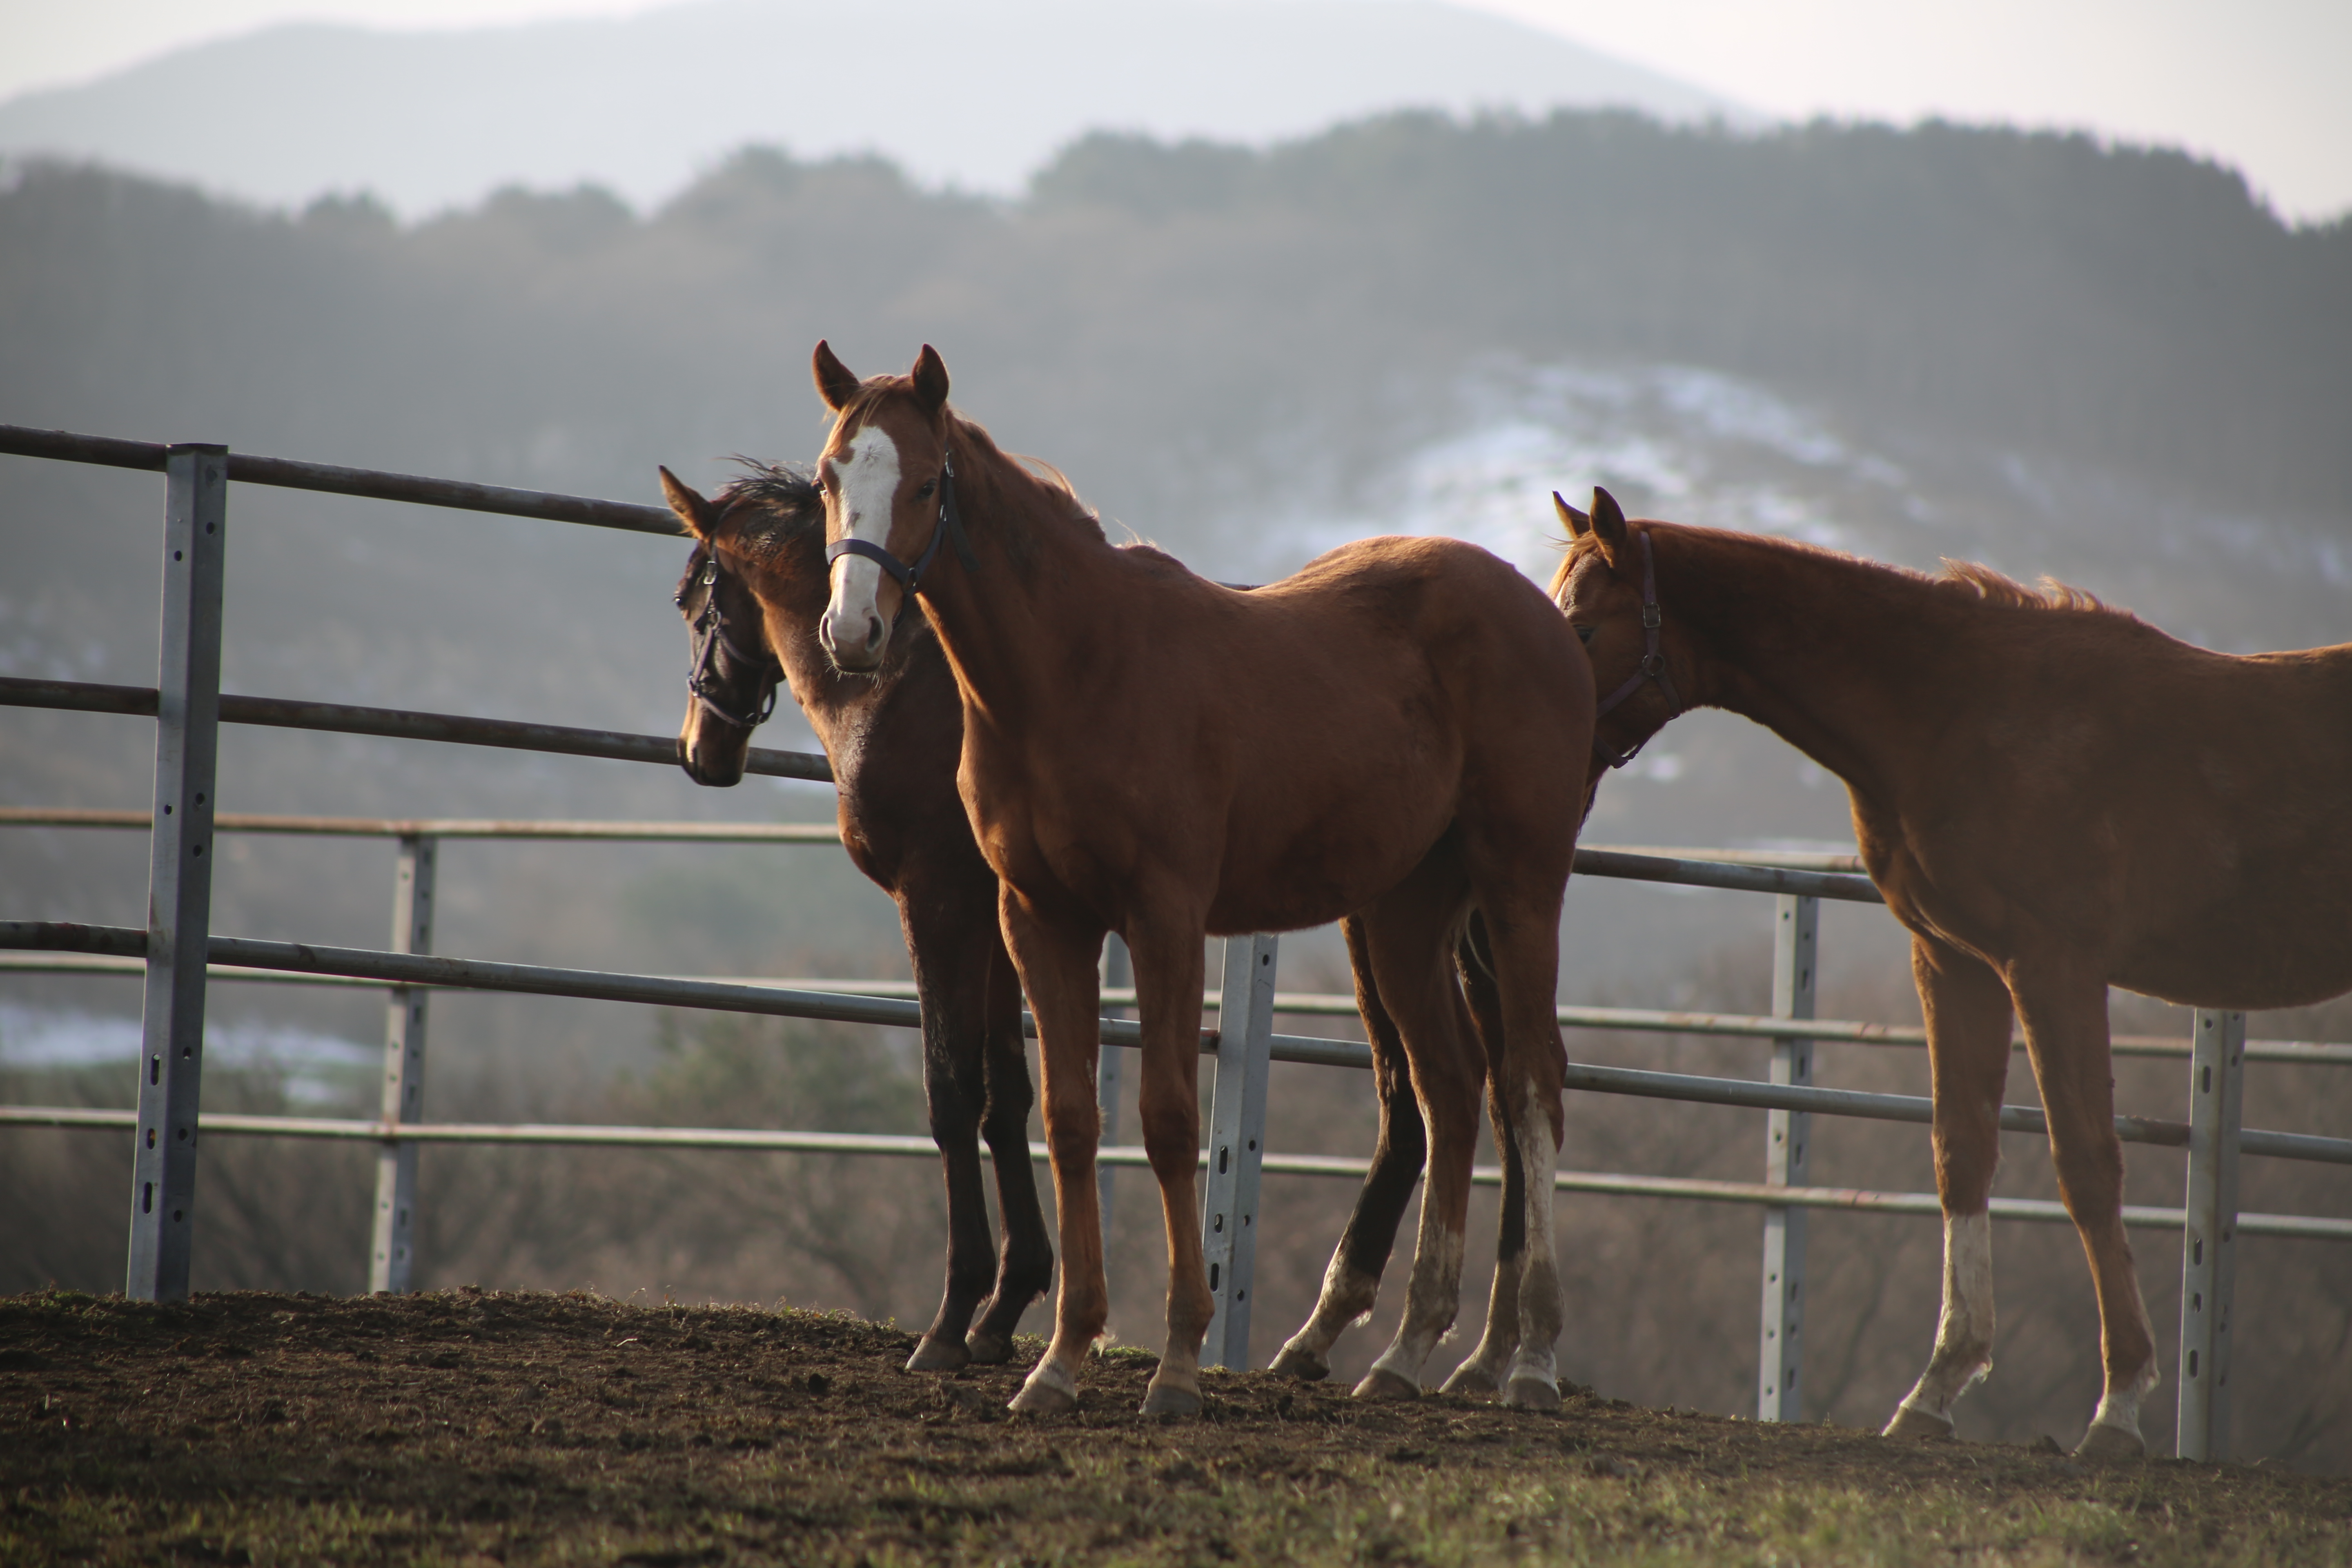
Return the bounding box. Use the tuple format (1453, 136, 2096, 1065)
(814, 343, 1592, 1413)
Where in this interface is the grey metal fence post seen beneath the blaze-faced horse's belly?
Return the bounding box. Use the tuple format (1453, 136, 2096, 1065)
(1200, 935, 1275, 1373)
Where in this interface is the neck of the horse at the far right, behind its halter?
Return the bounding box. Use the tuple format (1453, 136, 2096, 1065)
(1661, 541, 1959, 795)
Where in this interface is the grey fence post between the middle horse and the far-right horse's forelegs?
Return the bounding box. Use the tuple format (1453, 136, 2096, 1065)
(1757, 893, 1820, 1420)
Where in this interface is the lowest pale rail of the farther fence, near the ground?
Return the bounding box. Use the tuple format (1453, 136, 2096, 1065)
(0, 1105, 2352, 1241)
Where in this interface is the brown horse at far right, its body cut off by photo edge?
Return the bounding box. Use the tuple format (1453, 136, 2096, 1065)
(1552, 489, 2352, 1457)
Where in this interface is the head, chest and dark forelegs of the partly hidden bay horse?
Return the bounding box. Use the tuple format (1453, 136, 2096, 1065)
(661, 468, 1054, 1370)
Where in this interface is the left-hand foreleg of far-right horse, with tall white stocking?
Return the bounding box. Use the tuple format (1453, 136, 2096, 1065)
(1886, 935, 2009, 1439)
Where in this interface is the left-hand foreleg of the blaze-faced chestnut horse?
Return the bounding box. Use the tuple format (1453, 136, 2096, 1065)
(997, 884, 1110, 1415)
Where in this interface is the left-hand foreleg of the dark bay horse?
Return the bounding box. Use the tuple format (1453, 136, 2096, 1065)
(898, 893, 995, 1373)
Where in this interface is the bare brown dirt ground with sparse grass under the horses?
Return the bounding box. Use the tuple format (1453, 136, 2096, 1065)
(0, 1291, 2352, 1563)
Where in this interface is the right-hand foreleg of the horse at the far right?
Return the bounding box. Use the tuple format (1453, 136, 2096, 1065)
(2009, 962, 2157, 1460)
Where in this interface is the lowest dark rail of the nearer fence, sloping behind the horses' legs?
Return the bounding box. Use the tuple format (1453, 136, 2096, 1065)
(0, 919, 2352, 1164)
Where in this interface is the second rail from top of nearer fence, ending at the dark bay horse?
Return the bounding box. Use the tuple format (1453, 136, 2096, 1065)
(0, 675, 833, 783)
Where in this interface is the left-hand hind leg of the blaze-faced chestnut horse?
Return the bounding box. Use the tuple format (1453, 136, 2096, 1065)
(1355, 851, 1482, 1399)
